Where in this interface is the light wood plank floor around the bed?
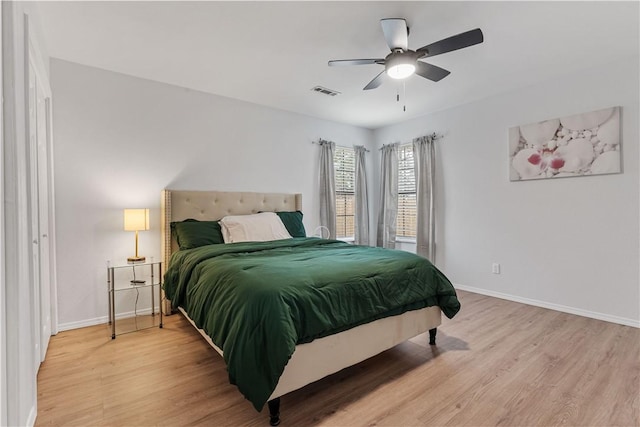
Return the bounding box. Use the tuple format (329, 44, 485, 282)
(36, 291, 640, 426)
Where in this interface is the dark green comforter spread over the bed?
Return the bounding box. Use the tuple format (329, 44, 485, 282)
(164, 238, 460, 410)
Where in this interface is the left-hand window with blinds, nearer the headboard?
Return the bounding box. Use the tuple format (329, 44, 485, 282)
(333, 147, 356, 238)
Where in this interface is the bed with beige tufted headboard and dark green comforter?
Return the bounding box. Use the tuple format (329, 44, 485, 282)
(161, 190, 460, 425)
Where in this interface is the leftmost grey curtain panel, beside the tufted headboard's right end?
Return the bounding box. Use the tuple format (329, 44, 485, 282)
(318, 139, 336, 239)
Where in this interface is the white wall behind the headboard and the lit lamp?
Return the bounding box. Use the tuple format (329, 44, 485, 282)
(50, 59, 372, 329)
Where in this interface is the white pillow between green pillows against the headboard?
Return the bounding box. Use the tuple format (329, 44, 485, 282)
(220, 212, 291, 243)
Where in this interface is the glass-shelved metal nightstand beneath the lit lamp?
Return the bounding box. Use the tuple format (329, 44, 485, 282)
(107, 261, 162, 339)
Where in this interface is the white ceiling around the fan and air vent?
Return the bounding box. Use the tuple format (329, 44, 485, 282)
(38, 1, 639, 129)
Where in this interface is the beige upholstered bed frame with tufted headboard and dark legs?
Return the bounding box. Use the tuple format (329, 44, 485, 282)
(161, 190, 441, 426)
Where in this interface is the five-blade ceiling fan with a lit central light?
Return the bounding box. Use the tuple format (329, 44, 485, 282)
(329, 18, 484, 90)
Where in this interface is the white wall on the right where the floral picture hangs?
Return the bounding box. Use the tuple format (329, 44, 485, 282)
(373, 57, 640, 326)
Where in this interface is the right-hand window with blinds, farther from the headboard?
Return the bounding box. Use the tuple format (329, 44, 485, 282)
(396, 144, 417, 239)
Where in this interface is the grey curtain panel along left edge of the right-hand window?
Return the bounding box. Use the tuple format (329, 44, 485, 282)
(376, 143, 399, 249)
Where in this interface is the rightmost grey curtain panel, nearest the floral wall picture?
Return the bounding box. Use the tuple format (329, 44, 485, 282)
(413, 135, 436, 263)
